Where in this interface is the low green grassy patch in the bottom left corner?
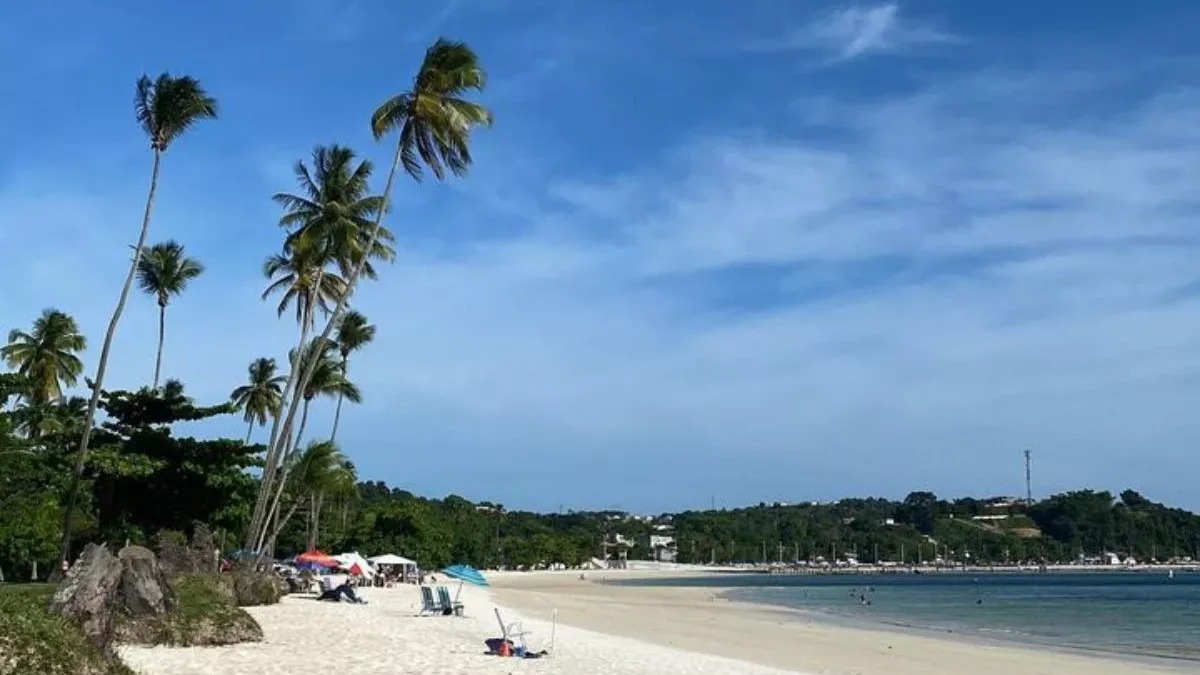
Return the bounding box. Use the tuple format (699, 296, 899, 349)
(0, 584, 134, 675)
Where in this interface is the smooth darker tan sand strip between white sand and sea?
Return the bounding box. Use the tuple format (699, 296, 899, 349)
(492, 571, 1196, 675)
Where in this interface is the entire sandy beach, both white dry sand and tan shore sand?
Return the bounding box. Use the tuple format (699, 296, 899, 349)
(121, 572, 1196, 675)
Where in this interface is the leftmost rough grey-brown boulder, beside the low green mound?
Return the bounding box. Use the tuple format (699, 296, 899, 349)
(50, 544, 121, 651)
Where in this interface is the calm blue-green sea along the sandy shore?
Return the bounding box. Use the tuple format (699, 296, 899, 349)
(630, 572, 1200, 661)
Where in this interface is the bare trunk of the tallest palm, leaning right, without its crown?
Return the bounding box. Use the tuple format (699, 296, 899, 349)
(247, 141, 403, 550)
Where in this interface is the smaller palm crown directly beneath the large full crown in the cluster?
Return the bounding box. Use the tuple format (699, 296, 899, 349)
(263, 238, 346, 344)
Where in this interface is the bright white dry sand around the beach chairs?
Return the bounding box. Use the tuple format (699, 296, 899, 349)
(120, 578, 786, 675)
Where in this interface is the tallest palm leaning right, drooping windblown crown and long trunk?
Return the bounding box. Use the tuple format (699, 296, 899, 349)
(246, 38, 492, 550)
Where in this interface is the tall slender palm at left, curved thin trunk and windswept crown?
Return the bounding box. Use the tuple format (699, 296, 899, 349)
(62, 73, 217, 560)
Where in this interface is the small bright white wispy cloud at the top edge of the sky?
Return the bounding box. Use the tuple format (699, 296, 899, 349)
(761, 2, 958, 62)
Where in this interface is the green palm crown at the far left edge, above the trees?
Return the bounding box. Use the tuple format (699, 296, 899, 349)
(0, 309, 88, 405)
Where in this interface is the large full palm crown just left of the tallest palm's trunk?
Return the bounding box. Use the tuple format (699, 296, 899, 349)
(274, 145, 396, 279)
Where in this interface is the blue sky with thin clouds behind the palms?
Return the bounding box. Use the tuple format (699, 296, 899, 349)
(0, 0, 1200, 510)
